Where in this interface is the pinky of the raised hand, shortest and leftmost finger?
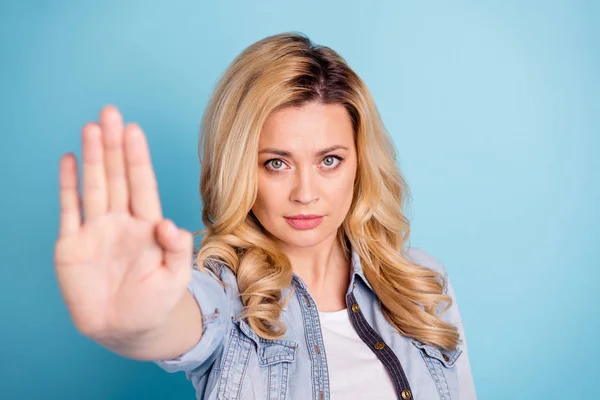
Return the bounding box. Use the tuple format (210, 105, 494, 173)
(58, 153, 81, 237)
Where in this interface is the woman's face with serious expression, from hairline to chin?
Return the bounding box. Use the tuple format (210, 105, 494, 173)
(252, 102, 357, 248)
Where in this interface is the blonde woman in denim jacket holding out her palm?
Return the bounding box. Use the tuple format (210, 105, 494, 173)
(55, 34, 475, 400)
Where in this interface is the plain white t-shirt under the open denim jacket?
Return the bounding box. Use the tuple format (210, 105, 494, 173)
(319, 309, 396, 400)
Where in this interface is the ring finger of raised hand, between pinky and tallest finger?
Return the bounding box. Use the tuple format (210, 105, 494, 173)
(82, 122, 108, 219)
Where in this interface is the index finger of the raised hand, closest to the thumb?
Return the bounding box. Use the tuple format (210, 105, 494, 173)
(125, 124, 162, 222)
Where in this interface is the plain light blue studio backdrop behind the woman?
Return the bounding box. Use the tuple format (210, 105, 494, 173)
(0, 0, 600, 399)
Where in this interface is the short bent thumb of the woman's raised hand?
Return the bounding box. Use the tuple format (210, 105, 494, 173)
(157, 219, 194, 272)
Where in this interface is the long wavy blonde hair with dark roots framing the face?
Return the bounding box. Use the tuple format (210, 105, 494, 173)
(196, 33, 459, 349)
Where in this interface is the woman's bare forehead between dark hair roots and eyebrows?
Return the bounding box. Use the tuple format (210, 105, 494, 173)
(259, 102, 354, 151)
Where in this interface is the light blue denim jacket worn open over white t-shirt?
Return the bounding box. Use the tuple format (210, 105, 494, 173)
(154, 248, 476, 400)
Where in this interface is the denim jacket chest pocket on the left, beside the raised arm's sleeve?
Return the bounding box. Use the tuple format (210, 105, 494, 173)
(217, 320, 298, 400)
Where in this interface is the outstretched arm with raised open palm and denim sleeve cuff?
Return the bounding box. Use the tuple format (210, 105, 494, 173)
(54, 106, 229, 376)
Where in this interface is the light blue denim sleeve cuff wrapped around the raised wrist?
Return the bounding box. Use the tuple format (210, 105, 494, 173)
(153, 260, 231, 379)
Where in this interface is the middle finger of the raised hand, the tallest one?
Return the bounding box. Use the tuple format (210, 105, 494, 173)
(100, 105, 129, 211)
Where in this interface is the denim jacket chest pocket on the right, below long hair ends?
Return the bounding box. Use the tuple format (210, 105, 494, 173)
(412, 339, 462, 400)
